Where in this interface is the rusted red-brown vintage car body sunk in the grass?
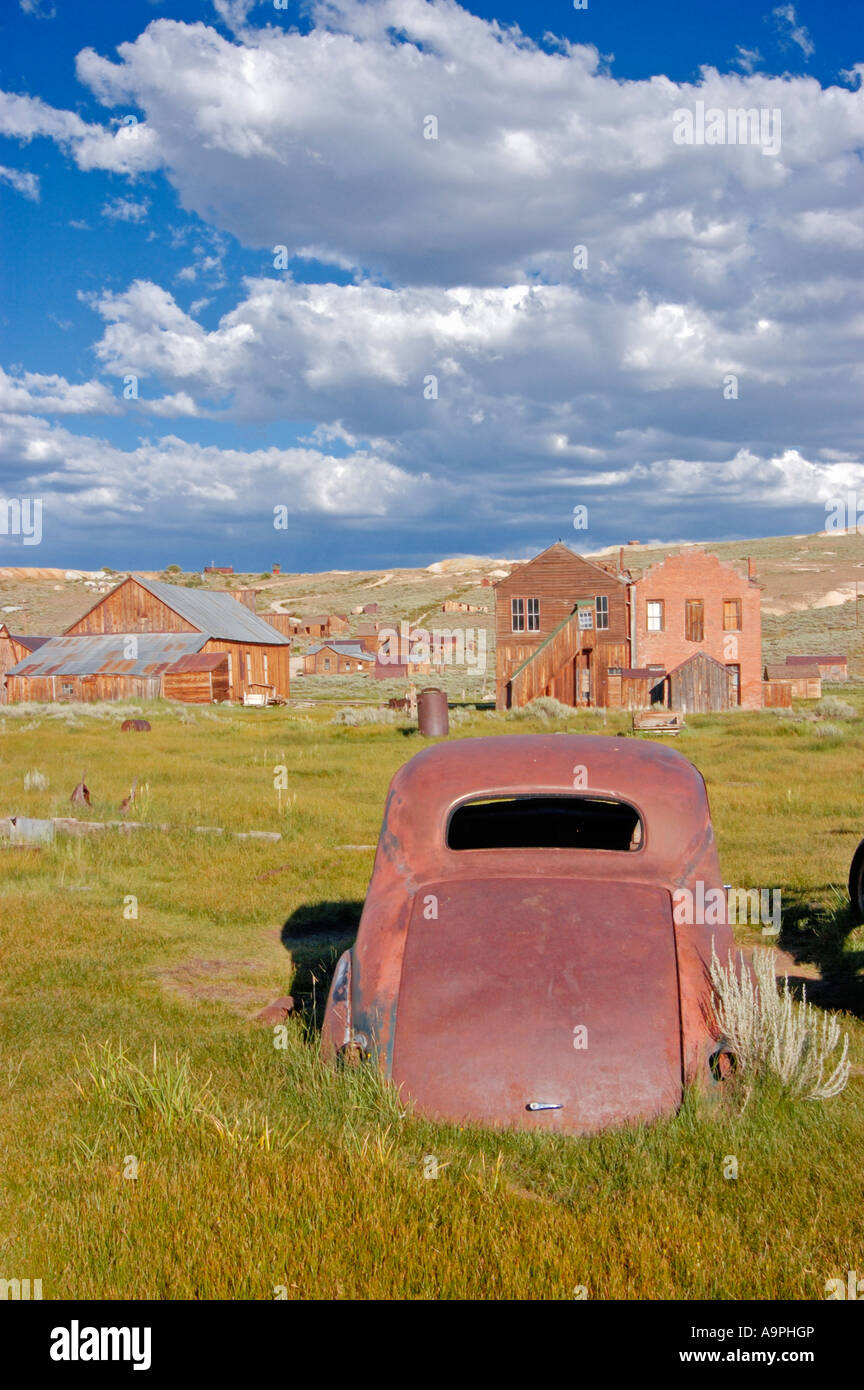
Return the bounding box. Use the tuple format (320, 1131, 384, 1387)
(322, 734, 732, 1134)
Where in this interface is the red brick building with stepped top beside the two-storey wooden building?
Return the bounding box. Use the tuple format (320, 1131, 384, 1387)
(632, 548, 763, 709)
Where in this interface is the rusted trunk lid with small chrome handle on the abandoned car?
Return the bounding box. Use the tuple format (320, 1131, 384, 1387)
(392, 877, 682, 1133)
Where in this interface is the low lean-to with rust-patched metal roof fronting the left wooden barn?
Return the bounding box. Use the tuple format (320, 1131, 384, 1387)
(6, 632, 209, 703)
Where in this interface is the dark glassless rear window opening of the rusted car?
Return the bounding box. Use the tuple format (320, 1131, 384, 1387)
(447, 796, 643, 851)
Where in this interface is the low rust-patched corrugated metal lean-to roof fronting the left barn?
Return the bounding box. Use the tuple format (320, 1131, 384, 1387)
(7, 632, 207, 676)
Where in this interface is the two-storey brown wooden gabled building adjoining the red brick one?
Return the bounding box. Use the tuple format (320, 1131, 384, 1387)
(495, 542, 631, 709)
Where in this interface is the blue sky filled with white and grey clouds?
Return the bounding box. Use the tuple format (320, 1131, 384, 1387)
(0, 0, 864, 570)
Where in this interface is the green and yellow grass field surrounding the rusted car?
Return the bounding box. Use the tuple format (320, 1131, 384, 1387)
(0, 695, 864, 1300)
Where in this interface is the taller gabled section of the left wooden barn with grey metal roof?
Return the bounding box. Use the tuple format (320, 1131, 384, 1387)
(34, 574, 290, 701)
